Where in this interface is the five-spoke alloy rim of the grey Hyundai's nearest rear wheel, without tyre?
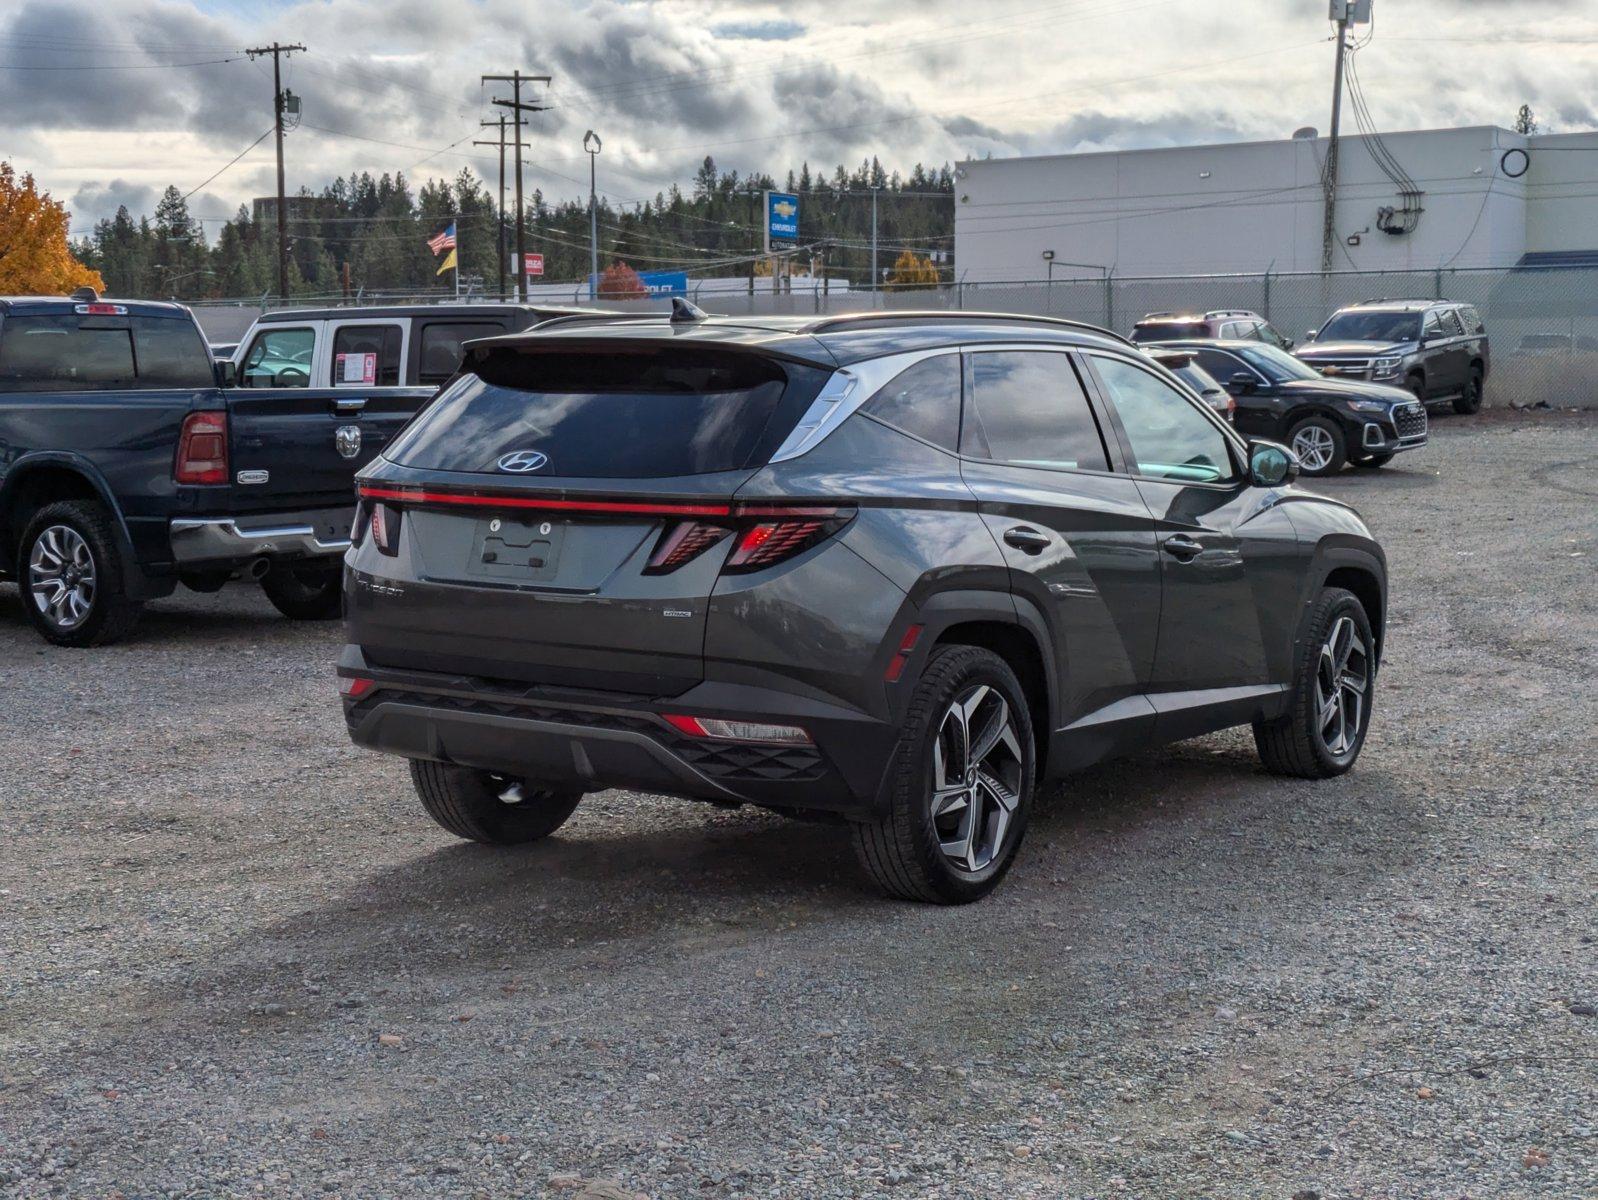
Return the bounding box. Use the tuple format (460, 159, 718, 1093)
(932, 684, 1024, 874)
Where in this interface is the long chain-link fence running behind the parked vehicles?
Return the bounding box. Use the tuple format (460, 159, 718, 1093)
(195, 267, 1598, 407)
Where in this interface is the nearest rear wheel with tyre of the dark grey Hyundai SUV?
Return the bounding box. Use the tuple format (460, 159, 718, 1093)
(855, 646, 1036, 904)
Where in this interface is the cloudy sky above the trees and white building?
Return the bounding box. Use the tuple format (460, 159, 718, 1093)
(0, 0, 1598, 230)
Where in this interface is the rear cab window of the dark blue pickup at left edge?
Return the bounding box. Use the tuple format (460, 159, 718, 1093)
(0, 313, 136, 391)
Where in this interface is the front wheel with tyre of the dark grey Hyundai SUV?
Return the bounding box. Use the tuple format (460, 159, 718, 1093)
(1254, 588, 1376, 780)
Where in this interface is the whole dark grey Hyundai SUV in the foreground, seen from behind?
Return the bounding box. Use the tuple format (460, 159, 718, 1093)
(339, 304, 1387, 903)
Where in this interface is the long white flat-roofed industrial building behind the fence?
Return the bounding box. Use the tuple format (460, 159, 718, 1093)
(954, 126, 1598, 283)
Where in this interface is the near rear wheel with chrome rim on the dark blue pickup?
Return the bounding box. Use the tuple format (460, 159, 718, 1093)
(16, 500, 142, 647)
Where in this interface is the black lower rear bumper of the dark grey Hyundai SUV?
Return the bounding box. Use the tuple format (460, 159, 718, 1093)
(339, 646, 896, 817)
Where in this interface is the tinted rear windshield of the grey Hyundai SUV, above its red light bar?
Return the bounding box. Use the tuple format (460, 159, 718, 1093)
(384, 348, 825, 479)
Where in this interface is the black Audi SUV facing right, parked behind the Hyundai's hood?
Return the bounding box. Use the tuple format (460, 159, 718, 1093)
(1160, 342, 1427, 475)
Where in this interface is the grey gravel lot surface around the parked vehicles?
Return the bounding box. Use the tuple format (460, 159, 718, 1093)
(0, 414, 1598, 1200)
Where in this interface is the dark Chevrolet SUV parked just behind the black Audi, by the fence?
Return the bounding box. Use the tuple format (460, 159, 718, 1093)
(1298, 300, 1491, 414)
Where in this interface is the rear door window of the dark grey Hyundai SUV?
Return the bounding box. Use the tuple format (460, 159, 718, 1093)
(960, 350, 1109, 471)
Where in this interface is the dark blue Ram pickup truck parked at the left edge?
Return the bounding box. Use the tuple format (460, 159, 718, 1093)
(0, 292, 436, 646)
